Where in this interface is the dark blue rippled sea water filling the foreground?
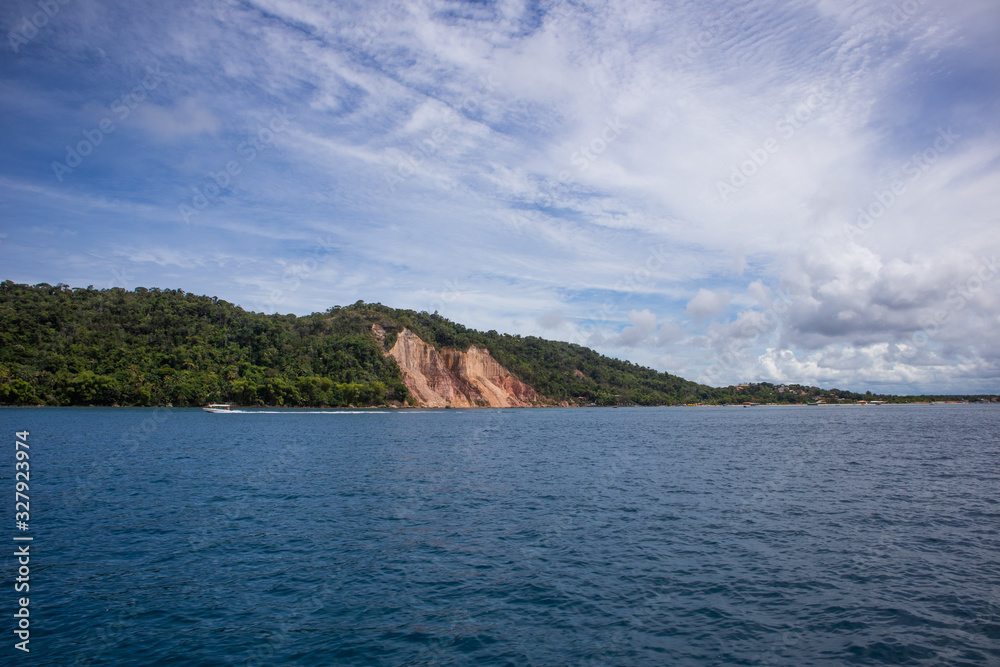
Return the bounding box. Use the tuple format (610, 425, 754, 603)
(0, 405, 1000, 666)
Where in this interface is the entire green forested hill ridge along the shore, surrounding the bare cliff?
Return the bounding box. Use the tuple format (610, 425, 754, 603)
(0, 281, 996, 406)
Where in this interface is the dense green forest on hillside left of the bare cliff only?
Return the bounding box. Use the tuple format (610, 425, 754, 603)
(0, 281, 407, 406)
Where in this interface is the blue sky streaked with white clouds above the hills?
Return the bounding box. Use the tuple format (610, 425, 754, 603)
(0, 0, 1000, 393)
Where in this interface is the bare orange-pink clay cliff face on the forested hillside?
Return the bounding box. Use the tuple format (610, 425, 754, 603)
(380, 324, 542, 408)
